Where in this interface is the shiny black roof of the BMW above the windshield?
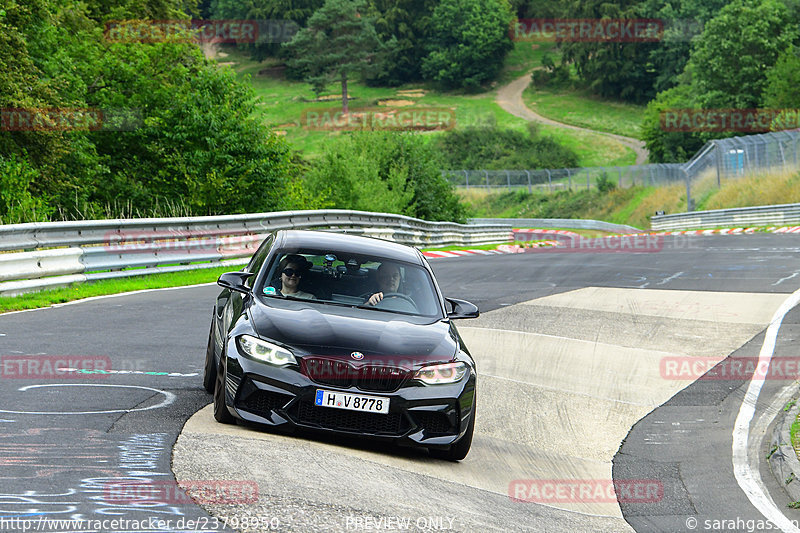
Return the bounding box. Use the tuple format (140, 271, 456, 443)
(275, 230, 422, 264)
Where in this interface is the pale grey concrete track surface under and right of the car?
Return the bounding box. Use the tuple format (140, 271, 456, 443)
(173, 287, 785, 532)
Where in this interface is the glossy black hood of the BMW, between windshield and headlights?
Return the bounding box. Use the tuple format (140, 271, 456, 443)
(250, 300, 458, 363)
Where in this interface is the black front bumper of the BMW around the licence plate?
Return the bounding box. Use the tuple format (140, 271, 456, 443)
(220, 342, 476, 448)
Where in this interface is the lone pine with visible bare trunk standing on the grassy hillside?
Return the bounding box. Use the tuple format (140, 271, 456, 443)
(284, 0, 395, 114)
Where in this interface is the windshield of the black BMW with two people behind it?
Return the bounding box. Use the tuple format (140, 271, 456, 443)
(257, 249, 442, 317)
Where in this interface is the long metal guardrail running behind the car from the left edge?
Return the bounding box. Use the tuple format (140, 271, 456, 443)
(0, 209, 512, 296)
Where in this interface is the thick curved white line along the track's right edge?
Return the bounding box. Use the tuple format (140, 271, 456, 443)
(732, 289, 800, 533)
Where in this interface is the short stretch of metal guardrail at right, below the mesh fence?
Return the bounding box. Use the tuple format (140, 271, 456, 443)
(650, 204, 800, 231)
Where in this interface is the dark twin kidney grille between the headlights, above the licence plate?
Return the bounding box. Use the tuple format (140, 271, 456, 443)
(303, 357, 410, 392)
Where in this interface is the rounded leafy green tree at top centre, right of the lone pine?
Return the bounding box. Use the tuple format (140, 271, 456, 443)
(422, 0, 514, 90)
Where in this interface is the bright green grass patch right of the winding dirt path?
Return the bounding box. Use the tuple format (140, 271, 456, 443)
(522, 86, 645, 139)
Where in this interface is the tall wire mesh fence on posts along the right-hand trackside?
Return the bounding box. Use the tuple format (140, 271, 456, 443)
(442, 130, 800, 211)
